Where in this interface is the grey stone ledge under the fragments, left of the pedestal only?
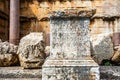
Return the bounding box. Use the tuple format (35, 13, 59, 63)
(0, 67, 42, 80)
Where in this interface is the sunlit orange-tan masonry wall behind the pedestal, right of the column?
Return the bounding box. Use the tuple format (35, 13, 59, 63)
(20, 0, 120, 45)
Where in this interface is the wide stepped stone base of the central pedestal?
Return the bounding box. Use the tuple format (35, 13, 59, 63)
(42, 59, 99, 80)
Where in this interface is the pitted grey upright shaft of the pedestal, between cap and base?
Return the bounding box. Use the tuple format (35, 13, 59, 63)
(50, 11, 90, 59)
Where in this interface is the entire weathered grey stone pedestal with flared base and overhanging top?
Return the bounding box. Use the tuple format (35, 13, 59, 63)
(42, 9, 99, 80)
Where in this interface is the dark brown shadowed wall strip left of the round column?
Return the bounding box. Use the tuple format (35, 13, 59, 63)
(0, 0, 9, 41)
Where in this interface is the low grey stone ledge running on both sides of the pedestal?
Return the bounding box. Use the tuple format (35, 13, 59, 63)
(0, 66, 120, 80)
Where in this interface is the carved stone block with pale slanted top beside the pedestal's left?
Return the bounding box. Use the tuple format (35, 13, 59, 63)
(17, 33, 45, 68)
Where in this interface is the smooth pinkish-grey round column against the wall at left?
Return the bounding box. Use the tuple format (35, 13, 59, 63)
(9, 0, 20, 44)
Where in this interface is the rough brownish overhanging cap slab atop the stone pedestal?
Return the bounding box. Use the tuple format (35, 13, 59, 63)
(50, 9, 96, 18)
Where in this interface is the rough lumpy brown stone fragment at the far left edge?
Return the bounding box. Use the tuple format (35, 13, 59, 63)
(0, 41, 18, 66)
